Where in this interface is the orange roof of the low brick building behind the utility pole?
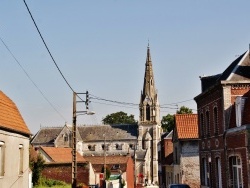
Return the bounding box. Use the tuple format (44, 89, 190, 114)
(40, 147, 86, 163)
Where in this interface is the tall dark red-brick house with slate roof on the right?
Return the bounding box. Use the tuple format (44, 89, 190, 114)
(195, 50, 250, 188)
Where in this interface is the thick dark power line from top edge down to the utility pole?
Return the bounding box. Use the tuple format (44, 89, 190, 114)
(23, 0, 74, 93)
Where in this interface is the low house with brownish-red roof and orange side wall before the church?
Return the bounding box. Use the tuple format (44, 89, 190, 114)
(84, 155, 135, 188)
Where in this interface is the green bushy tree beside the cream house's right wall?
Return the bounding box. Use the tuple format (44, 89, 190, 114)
(29, 146, 45, 185)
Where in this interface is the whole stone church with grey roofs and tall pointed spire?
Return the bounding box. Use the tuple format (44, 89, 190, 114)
(31, 46, 162, 185)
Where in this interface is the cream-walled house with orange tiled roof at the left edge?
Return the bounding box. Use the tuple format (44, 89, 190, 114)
(0, 91, 31, 188)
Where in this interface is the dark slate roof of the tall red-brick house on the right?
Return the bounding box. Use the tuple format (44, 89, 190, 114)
(201, 51, 250, 92)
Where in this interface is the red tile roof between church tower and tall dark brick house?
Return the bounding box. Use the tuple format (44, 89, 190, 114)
(175, 114, 199, 139)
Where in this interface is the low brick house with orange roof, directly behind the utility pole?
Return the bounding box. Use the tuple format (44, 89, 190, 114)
(37, 147, 90, 185)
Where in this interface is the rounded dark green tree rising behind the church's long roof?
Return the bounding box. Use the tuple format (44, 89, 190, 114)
(102, 111, 137, 124)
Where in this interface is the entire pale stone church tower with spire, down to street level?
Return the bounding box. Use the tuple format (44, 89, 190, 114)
(138, 45, 162, 184)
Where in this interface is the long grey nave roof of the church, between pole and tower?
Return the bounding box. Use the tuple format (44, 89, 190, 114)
(77, 124, 137, 142)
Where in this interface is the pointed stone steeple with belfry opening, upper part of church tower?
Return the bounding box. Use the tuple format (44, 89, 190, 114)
(140, 45, 159, 122)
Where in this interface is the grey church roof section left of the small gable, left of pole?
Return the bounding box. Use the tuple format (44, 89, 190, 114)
(31, 127, 63, 145)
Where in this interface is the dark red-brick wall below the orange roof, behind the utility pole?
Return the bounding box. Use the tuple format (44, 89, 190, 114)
(42, 163, 89, 185)
